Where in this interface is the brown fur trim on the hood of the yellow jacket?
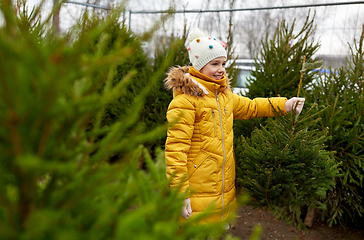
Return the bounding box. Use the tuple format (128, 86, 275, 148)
(164, 66, 230, 97)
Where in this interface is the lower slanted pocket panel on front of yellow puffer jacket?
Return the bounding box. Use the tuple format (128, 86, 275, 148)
(188, 151, 219, 195)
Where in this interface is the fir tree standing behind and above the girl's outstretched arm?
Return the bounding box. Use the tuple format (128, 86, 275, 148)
(247, 11, 320, 98)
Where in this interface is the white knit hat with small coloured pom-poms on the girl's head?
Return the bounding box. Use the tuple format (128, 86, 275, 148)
(186, 28, 227, 71)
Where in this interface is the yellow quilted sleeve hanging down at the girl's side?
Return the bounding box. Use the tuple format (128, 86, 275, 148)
(165, 94, 195, 192)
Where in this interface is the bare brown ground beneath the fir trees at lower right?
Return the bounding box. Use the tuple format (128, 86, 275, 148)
(229, 206, 364, 240)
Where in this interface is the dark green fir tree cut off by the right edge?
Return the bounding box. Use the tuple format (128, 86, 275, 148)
(307, 25, 364, 227)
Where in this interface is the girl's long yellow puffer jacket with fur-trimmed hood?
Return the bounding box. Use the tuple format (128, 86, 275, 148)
(165, 67, 287, 221)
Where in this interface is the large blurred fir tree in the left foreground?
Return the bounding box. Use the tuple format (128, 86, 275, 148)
(0, 1, 235, 239)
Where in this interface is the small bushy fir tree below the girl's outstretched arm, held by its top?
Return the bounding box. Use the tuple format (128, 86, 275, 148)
(237, 105, 339, 228)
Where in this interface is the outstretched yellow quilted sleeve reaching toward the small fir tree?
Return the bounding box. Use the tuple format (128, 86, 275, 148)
(233, 93, 287, 119)
